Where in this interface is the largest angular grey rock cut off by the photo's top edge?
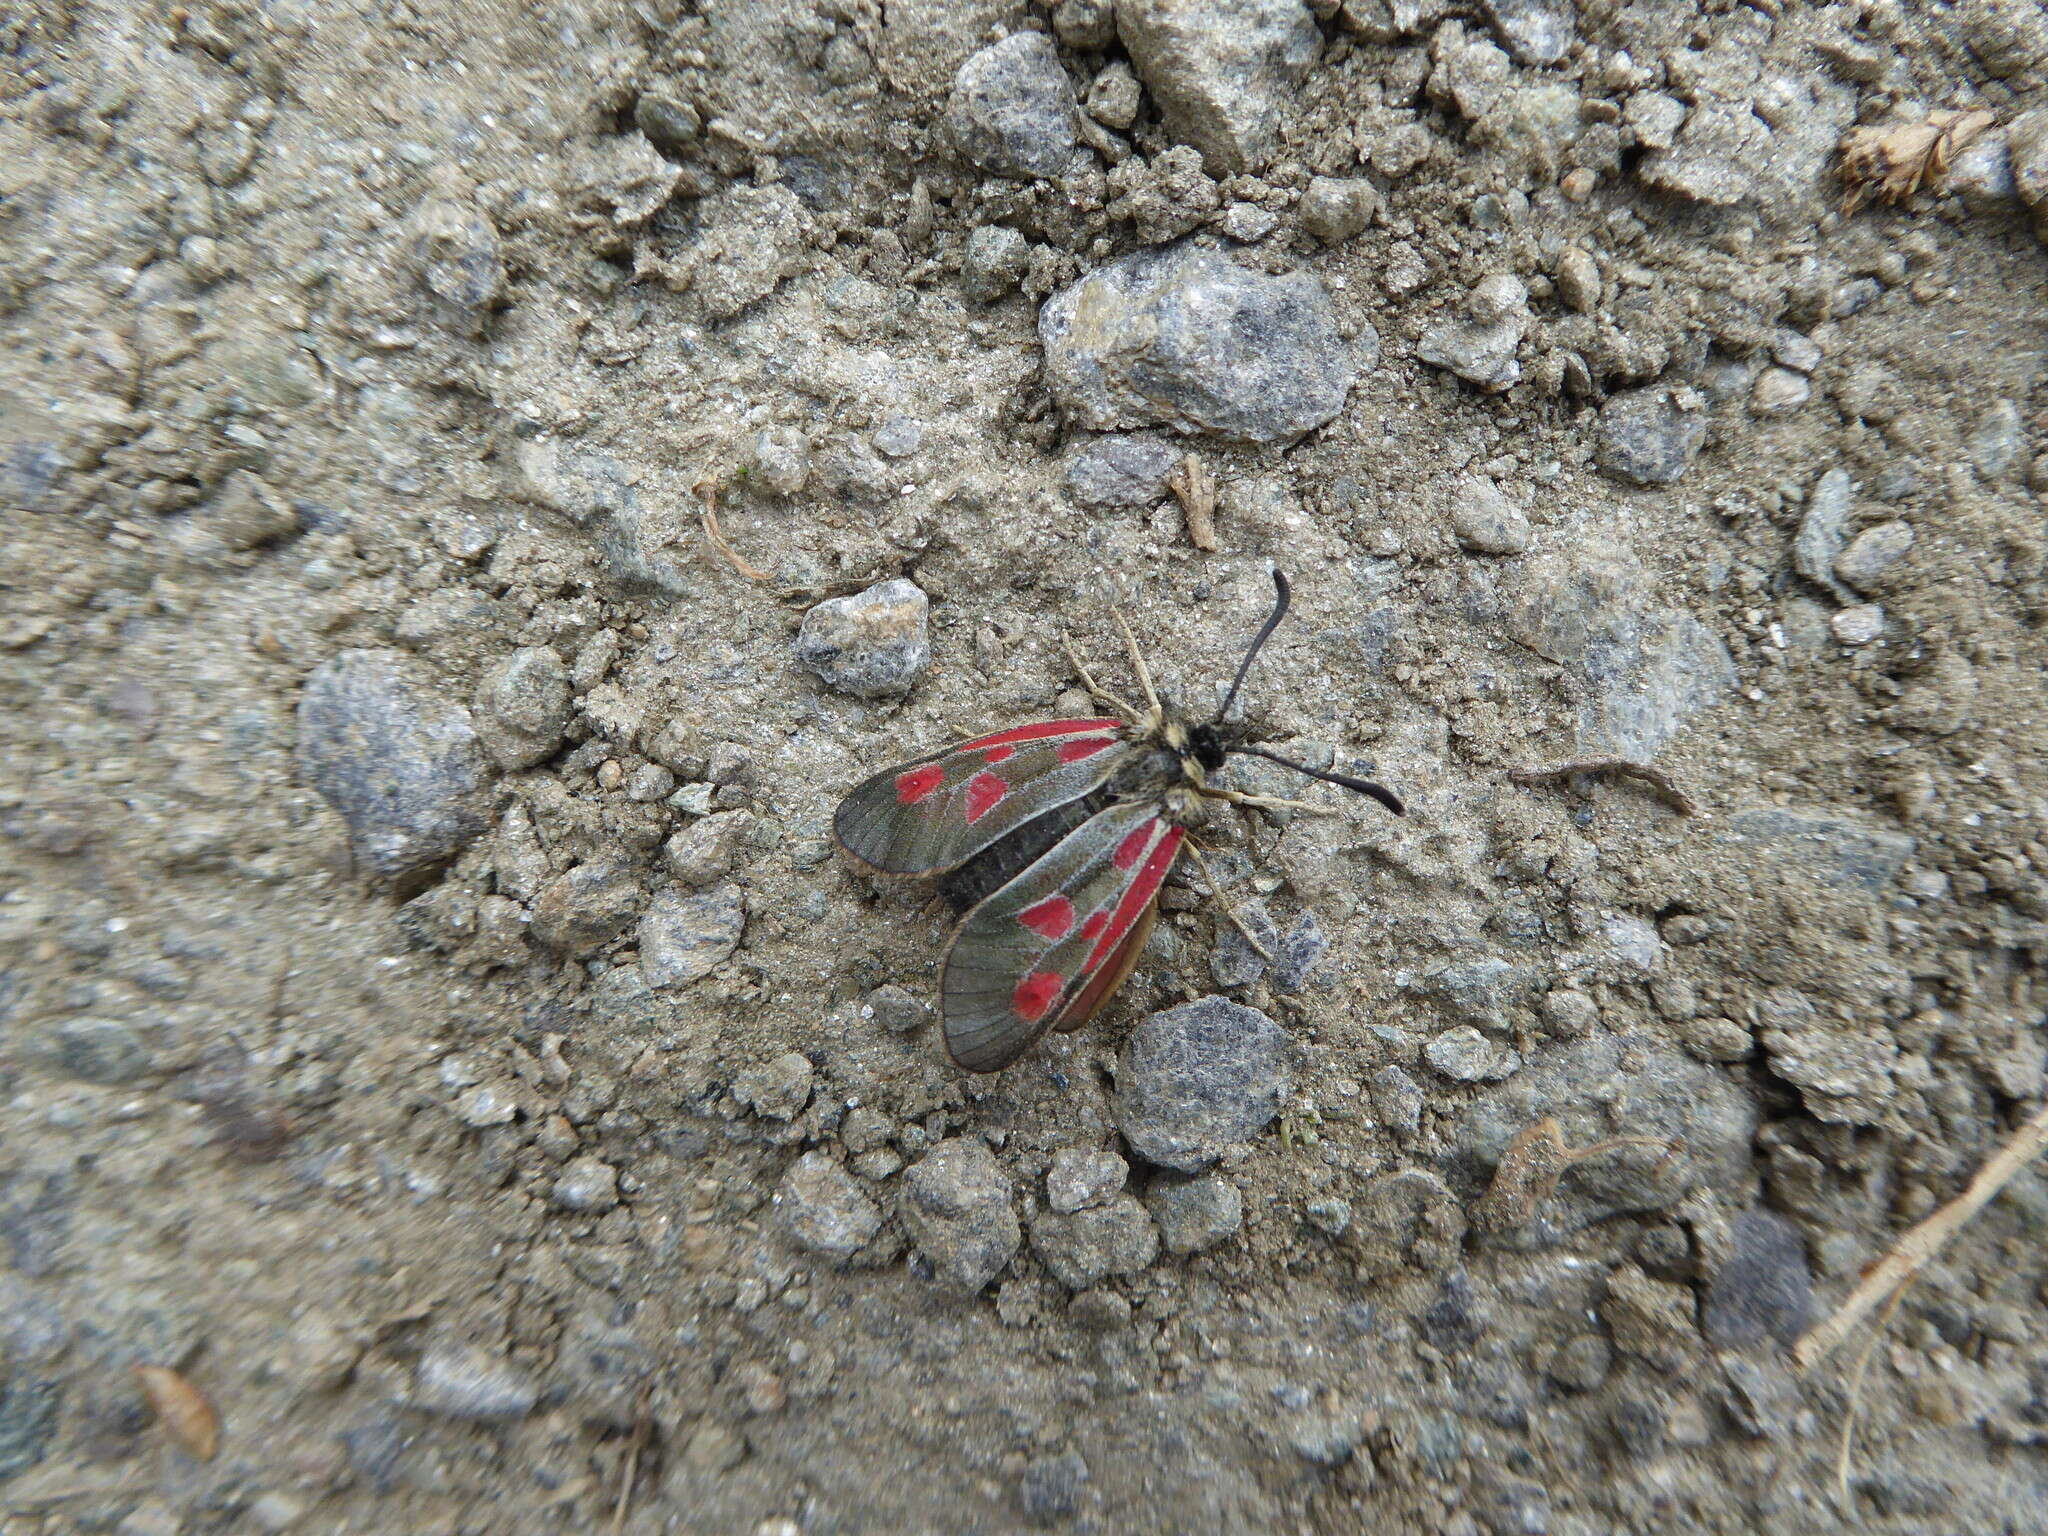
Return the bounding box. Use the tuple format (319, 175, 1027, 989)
(1116, 0, 1323, 176)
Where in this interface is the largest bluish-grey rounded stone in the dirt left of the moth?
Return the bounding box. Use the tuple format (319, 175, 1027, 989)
(299, 651, 487, 883)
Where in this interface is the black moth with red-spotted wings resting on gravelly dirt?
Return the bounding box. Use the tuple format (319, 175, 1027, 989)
(831, 569, 1405, 1071)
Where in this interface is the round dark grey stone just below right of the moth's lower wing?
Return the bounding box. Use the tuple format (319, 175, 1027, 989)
(1116, 997, 1290, 1174)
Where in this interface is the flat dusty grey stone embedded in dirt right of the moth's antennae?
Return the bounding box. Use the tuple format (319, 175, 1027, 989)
(1507, 541, 1735, 762)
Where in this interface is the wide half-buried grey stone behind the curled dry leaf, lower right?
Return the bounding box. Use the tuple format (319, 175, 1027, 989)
(1446, 1034, 1757, 1247)
